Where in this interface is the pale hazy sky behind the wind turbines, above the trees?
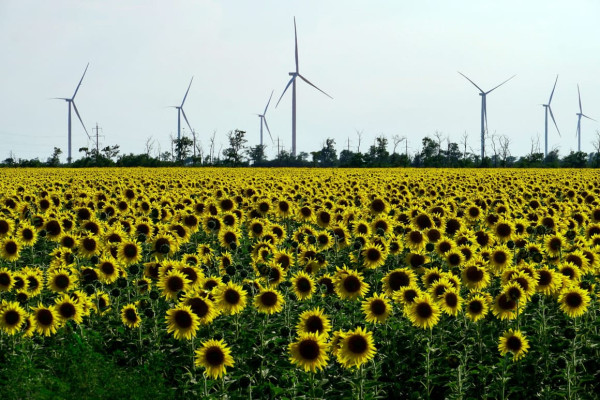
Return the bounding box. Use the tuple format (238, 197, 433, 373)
(0, 0, 600, 160)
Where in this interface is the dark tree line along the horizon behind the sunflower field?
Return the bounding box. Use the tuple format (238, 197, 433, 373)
(0, 129, 600, 168)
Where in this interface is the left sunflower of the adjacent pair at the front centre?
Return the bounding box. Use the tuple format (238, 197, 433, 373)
(288, 333, 329, 372)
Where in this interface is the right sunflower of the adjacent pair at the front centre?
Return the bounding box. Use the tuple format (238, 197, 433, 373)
(337, 327, 376, 368)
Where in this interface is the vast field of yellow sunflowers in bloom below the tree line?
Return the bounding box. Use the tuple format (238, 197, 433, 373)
(0, 168, 600, 399)
